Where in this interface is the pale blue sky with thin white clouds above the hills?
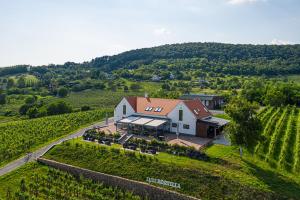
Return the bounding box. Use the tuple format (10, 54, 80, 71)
(0, 0, 300, 67)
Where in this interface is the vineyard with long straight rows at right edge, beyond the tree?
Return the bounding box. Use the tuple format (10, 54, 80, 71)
(256, 106, 300, 174)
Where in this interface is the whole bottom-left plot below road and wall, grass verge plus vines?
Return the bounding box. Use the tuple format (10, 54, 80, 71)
(0, 163, 141, 200)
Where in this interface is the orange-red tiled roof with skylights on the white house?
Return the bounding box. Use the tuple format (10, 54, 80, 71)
(126, 97, 211, 118)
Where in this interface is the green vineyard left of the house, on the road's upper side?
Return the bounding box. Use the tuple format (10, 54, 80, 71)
(0, 109, 112, 166)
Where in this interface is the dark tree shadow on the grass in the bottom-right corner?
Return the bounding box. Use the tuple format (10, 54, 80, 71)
(243, 160, 300, 199)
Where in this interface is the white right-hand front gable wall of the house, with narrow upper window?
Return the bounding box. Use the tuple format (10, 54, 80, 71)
(168, 103, 197, 135)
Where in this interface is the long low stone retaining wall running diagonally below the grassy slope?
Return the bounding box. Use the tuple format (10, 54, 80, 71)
(38, 158, 197, 200)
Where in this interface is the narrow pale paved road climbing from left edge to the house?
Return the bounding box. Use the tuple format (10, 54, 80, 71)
(0, 118, 113, 176)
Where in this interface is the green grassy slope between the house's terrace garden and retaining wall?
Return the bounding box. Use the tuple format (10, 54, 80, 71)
(44, 138, 300, 199)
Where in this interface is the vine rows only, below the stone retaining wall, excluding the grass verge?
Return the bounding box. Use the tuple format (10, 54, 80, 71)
(6, 168, 140, 200)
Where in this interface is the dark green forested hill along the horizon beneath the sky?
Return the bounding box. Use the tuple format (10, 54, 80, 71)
(0, 43, 300, 76)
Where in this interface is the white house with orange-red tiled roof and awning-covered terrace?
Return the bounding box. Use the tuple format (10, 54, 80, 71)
(114, 96, 228, 137)
